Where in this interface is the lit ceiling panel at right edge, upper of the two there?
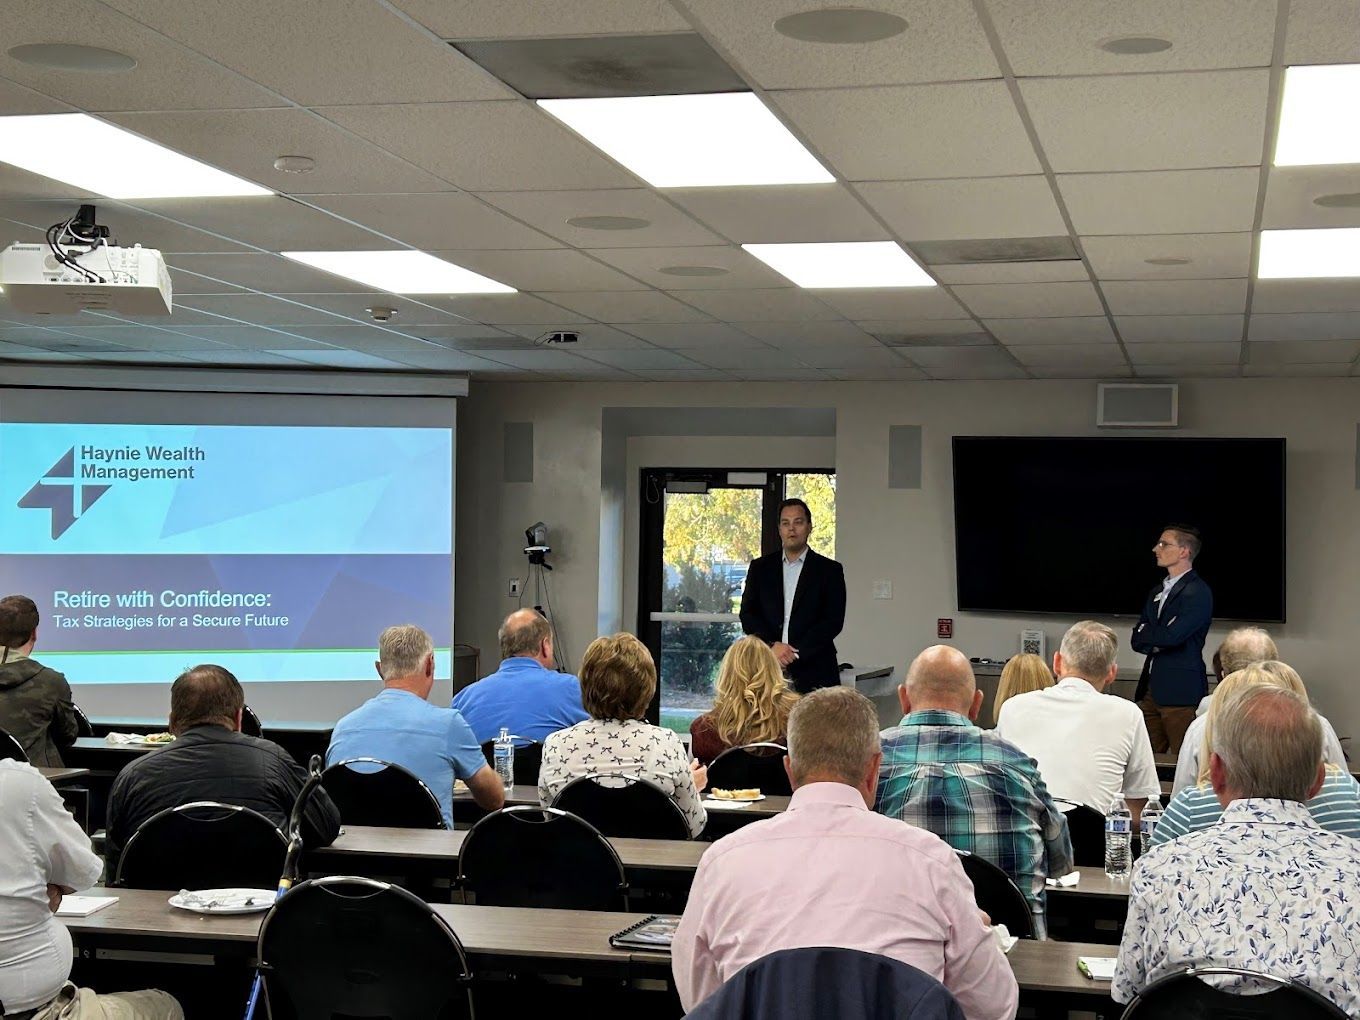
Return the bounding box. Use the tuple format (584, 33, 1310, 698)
(1274, 64, 1360, 166)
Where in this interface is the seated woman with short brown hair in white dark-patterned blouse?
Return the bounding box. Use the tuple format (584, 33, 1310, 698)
(539, 634, 709, 836)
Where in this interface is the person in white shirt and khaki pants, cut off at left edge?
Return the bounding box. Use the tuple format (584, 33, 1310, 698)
(0, 762, 184, 1020)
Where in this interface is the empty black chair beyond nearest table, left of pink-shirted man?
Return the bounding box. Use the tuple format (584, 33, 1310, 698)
(458, 806, 628, 910)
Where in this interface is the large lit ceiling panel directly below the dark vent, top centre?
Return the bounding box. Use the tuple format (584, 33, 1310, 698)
(539, 92, 835, 188)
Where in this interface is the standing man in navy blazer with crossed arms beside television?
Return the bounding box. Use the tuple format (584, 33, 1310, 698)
(1130, 524, 1213, 753)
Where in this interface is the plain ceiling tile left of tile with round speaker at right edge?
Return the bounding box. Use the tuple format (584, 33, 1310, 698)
(1058, 167, 1259, 235)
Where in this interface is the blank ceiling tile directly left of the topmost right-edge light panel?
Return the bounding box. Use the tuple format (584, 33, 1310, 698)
(1020, 68, 1270, 174)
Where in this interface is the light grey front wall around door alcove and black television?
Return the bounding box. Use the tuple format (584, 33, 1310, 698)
(456, 379, 1360, 736)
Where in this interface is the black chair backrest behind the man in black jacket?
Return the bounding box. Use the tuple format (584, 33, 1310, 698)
(114, 801, 288, 889)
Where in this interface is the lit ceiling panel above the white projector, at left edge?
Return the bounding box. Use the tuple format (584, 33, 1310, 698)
(0, 113, 272, 199)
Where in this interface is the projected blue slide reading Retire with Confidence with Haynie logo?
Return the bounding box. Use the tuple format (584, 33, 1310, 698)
(0, 423, 453, 684)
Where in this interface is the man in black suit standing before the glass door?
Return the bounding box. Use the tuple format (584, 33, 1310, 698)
(741, 499, 846, 694)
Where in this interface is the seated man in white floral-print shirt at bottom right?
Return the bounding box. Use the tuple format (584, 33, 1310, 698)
(1111, 684, 1360, 1016)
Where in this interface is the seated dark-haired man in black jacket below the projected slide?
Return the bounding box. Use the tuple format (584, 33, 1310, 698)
(105, 665, 340, 879)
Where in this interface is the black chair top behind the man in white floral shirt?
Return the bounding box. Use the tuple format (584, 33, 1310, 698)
(1121, 967, 1346, 1020)
